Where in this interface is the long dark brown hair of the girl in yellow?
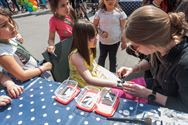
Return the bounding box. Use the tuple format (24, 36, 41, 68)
(71, 20, 97, 65)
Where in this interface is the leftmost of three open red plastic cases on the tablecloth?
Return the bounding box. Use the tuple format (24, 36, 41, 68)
(54, 80, 80, 105)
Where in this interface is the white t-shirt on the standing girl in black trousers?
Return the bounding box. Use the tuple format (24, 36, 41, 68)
(94, 9, 127, 45)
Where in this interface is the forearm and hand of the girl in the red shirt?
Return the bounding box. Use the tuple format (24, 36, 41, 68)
(47, 32, 55, 53)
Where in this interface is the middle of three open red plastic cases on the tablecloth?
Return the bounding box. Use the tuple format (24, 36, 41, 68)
(76, 86, 100, 112)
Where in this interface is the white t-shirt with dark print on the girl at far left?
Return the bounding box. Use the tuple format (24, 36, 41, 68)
(0, 38, 38, 70)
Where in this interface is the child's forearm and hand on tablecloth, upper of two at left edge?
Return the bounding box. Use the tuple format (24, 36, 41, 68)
(0, 74, 23, 98)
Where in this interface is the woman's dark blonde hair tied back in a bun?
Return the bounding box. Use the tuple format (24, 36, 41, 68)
(125, 5, 188, 47)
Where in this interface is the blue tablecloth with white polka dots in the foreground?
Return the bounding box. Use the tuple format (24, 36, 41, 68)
(0, 77, 188, 125)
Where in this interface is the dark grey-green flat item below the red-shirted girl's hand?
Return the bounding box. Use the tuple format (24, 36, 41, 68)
(42, 37, 72, 82)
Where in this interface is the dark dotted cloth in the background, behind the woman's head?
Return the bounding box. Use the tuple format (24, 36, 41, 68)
(119, 0, 142, 16)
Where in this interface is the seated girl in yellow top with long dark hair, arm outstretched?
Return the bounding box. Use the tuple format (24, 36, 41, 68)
(69, 20, 123, 90)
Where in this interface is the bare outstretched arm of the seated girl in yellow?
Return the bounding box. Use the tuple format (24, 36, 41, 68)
(70, 53, 117, 87)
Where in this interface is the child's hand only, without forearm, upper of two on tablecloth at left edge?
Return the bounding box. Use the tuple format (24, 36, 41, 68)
(6, 84, 24, 98)
